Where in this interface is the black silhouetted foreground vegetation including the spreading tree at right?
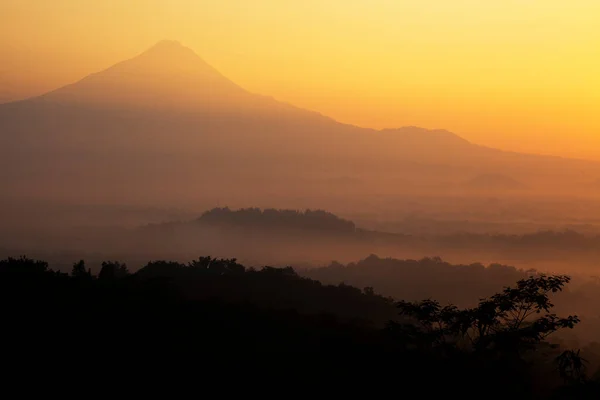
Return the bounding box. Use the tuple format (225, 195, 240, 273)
(0, 257, 600, 398)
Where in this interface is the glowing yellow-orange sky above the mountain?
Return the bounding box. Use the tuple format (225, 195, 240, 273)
(0, 0, 600, 159)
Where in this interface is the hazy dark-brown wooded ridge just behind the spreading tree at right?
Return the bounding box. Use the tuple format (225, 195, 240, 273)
(300, 255, 600, 347)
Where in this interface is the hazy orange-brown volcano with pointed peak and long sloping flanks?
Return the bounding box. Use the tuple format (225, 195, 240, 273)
(0, 41, 600, 207)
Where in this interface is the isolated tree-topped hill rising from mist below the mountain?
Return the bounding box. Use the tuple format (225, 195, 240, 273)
(133, 208, 369, 266)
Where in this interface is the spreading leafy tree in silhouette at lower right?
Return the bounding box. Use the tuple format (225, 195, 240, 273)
(388, 275, 579, 356)
